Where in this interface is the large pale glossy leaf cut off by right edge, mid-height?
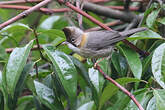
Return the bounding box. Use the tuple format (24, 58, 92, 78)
(151, 43, 165, 88)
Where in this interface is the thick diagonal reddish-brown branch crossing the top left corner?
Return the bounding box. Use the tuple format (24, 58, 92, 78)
(0, 0, 51, 29)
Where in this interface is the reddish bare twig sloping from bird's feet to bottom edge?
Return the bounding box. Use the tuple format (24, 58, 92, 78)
(96, 64, 144, 110)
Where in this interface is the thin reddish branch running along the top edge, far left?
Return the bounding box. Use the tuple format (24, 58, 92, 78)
(0, 0, 43, 5)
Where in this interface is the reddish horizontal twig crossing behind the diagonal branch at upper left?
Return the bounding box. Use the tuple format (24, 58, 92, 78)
(0, 5, 70, 14)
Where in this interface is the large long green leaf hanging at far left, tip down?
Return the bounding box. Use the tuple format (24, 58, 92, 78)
(6, 41, 33, 96)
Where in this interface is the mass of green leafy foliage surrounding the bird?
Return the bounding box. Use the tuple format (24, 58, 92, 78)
(0, 1, 165, 110)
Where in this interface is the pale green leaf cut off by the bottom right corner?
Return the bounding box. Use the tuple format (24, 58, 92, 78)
(154, 89, 165, 110)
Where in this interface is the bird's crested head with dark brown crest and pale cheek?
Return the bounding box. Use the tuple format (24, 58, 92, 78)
(63, 26, 84, 46)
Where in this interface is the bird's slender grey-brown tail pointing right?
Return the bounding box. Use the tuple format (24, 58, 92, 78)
(120, 27, 147, 37)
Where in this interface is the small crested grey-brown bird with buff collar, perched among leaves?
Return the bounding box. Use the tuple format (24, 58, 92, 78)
(63, 26, 147, 58)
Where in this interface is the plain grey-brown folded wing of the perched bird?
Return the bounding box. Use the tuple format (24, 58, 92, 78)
(86, 31, 125, 50)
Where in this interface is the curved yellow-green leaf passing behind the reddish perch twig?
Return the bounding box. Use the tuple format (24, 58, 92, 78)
(99, 78, 141, 110)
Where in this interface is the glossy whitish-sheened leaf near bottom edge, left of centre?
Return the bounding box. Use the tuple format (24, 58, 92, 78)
(34, 81, 58, 110)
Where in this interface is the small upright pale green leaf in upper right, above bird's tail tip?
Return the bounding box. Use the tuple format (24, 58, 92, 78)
(146, 9, 160, 28)
